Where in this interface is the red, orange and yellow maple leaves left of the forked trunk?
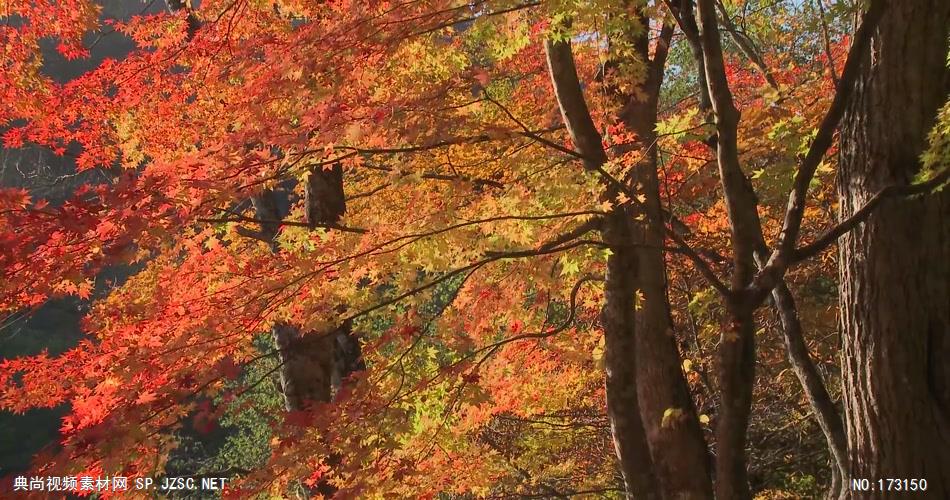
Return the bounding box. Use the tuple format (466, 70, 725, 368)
(0, 0, 872, 497)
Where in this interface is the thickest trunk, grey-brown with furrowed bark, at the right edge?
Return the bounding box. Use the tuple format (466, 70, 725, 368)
(838, 0, 950, 498)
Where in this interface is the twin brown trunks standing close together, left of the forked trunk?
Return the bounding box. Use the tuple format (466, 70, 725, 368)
(545, 27, 712, 498)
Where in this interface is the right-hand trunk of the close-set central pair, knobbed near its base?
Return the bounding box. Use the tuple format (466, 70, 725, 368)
(625, 99, 712, 499)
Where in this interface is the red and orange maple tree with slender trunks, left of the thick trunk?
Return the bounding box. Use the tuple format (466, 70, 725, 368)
(0, 0, 950, 499)
